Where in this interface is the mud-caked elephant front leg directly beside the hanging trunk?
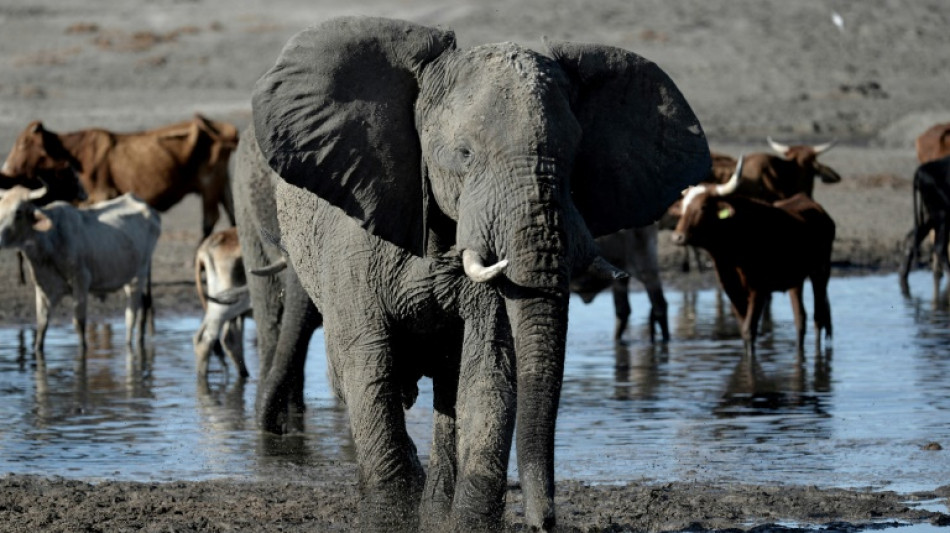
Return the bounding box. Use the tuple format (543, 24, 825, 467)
(452, 303, 517, 531)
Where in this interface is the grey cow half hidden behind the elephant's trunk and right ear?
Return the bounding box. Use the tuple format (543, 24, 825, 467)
(571, 223, 670, 343)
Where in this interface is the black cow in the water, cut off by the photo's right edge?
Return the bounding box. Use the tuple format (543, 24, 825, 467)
(900, 155, 950, 296)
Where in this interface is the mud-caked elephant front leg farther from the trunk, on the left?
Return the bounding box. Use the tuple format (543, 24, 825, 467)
(332, 324, 425, 532)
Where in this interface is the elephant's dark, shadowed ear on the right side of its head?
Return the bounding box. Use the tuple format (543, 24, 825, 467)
(547, 42, 711, 237)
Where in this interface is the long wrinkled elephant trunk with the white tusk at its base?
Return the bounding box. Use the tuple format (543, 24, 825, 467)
(458, 157, 595, 530)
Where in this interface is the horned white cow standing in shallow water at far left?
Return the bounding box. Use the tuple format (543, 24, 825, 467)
(0, 186, 161, 355)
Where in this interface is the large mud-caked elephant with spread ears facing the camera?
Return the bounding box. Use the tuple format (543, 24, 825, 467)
(249, 18, 710, 529)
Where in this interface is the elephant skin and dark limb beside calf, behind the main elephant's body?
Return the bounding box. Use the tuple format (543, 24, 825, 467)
(231, 141, 322, 433)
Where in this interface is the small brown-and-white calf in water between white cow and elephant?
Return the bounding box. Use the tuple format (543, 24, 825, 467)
(193, 227, 250, 379)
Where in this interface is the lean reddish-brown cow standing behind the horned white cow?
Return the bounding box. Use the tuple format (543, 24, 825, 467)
(0, 113, 238, 237)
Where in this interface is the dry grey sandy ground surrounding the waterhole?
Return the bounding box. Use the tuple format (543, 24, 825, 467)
(0, 0, 950, 531)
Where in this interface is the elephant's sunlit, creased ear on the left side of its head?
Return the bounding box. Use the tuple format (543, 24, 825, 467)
(252, 17, 455, 254)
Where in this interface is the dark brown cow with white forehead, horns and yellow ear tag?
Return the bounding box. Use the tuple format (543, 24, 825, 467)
(673, 158, 835, 355)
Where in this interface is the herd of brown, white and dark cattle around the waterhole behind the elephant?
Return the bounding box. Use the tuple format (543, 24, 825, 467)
(0, 114, 950, 370)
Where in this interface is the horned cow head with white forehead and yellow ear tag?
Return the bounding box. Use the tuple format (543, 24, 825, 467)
(672, 156, 743, 246)
